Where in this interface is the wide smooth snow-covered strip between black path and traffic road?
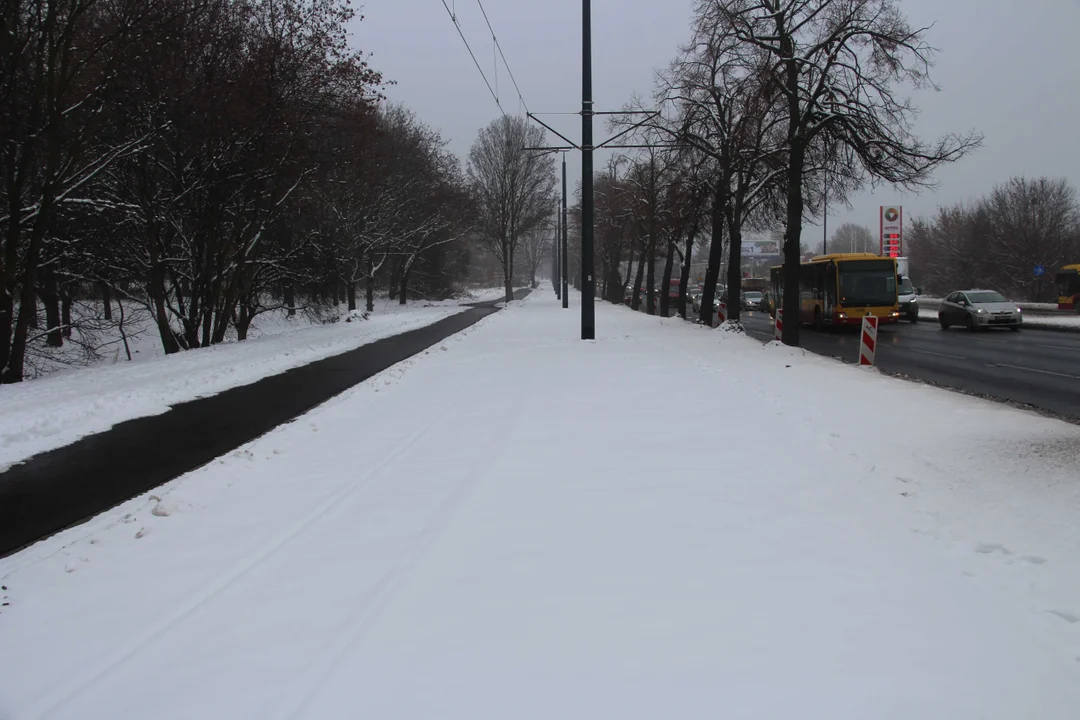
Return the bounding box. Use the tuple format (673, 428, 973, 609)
(0, 287, 1080, 720)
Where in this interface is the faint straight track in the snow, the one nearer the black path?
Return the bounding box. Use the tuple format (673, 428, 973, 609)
(30, 391, 461, 718)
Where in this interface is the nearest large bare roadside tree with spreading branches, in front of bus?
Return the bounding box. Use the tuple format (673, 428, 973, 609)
(699, 0, 982, 345)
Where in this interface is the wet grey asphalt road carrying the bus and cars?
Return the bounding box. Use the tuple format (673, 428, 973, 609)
(742, 312, 1080, 420)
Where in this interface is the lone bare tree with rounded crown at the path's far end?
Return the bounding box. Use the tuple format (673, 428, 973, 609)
(467, 116, 555, 302)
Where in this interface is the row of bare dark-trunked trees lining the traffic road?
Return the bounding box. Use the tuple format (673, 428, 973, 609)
(596, 0, 982, 344)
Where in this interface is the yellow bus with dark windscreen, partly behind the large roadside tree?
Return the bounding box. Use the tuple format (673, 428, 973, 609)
(772, 253, 900, 328)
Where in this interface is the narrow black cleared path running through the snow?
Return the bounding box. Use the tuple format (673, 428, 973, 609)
(0, 290, 529, 557)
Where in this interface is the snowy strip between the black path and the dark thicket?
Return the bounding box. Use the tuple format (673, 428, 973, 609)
(0, 288, 502, 470)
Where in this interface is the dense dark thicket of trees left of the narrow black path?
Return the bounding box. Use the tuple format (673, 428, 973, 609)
(0, 0, 529, 382)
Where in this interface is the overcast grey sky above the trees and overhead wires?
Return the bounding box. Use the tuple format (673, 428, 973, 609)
(353, 0, 1080, 243)
